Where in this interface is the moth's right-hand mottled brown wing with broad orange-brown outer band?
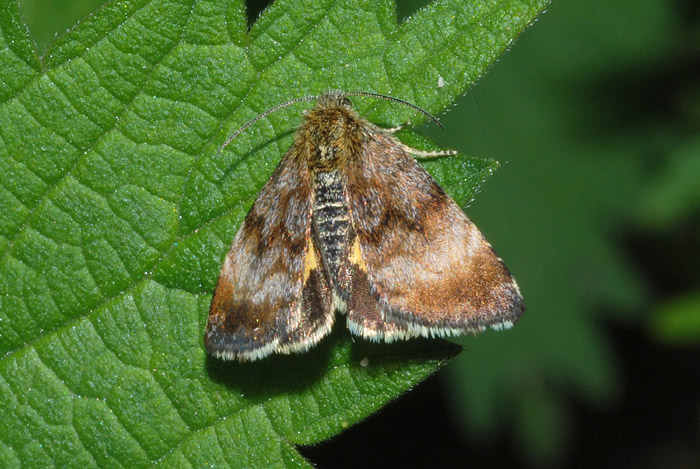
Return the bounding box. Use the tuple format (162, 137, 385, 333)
(347, 128, 524, 341)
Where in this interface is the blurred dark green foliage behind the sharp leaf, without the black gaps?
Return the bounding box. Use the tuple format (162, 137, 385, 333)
(16, 0, 700, 463)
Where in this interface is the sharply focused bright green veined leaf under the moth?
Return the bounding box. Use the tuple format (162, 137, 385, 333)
(0, 0, 546, 467)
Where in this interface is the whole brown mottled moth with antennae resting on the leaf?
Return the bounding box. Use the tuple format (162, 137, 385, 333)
(204, 91, 525, 361)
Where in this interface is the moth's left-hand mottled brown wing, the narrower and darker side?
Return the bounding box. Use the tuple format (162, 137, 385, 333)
(204, 144, 334, 361)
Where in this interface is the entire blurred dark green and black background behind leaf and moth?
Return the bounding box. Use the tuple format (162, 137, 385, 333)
(21, 0, 700, 468)
